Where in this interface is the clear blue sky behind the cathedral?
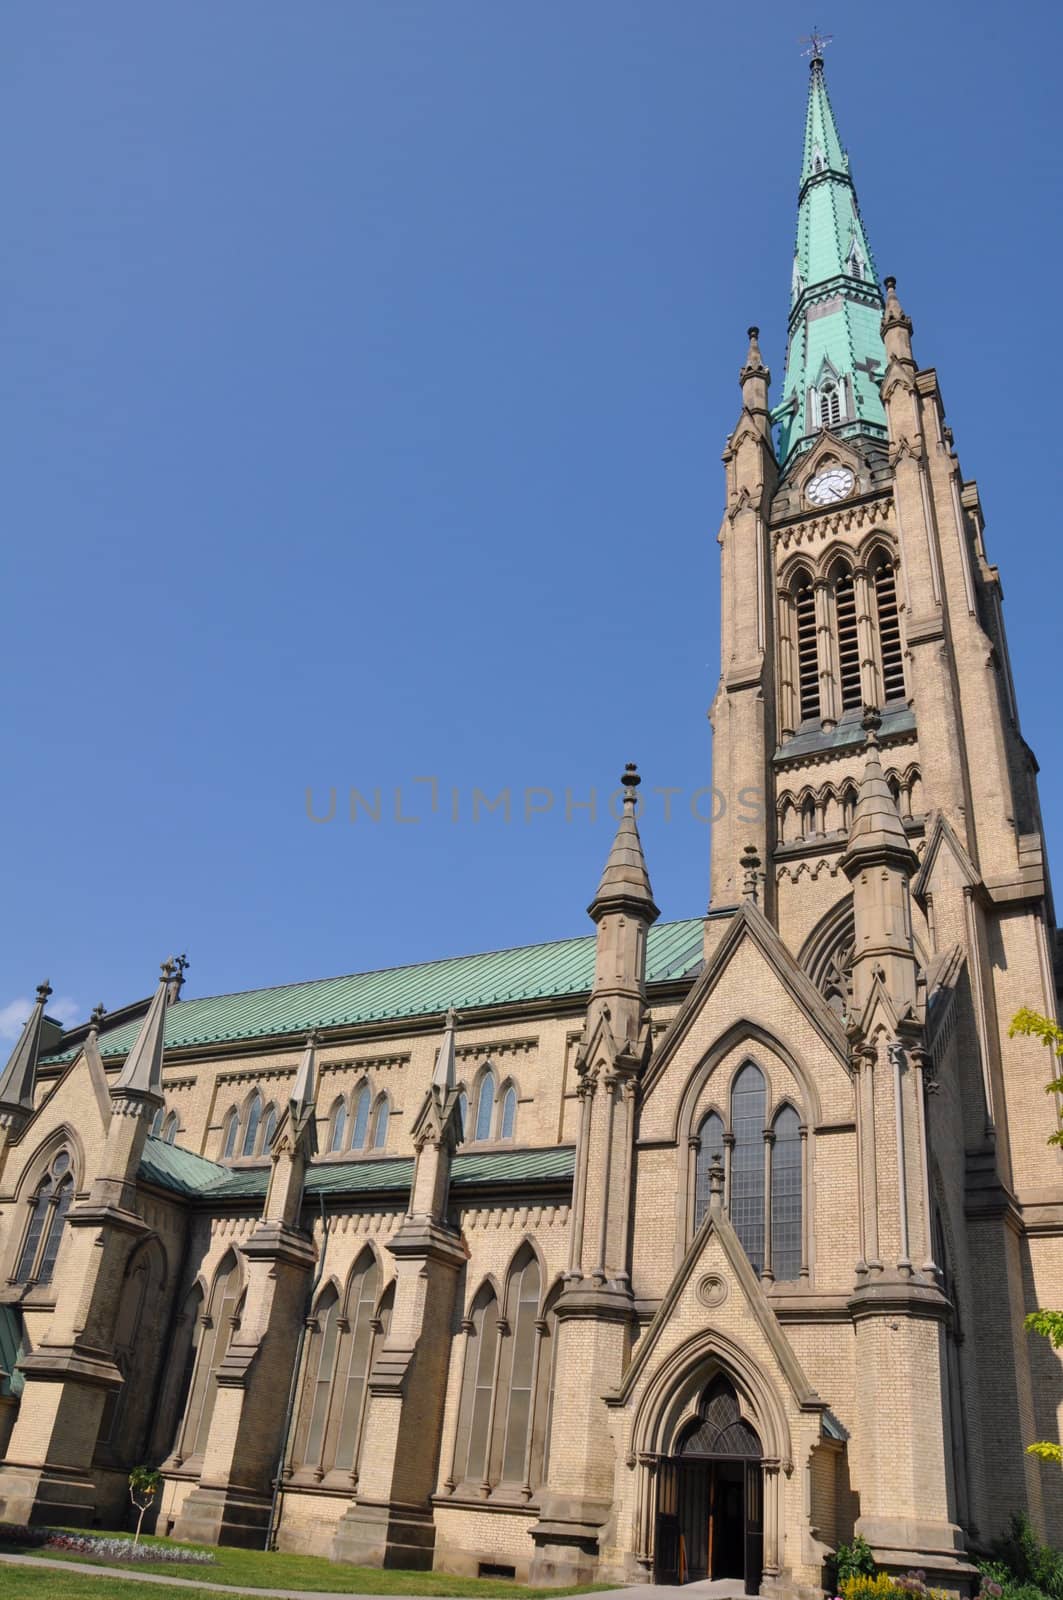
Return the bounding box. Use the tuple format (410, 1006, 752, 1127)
(0, 0, 1063, 1034)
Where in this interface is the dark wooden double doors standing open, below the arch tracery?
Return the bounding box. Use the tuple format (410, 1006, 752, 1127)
(655, 1454, 764, 1595)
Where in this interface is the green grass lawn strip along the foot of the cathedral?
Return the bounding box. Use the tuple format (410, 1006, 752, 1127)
(0, 1530, 604, 1600)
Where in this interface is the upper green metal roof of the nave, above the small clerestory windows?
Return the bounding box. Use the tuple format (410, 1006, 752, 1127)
(46, 917, 703, 1062)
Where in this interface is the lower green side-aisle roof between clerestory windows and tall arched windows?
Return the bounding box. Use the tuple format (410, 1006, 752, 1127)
(138, 1138, 575, 1203)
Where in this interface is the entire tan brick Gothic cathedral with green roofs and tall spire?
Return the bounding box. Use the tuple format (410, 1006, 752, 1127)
(0, 53, 1063, 1600)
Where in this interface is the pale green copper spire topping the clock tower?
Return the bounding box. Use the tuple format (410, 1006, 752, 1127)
(773, 54, 885, 464)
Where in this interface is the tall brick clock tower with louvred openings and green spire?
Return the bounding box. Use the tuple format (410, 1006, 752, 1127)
(706, 40, 1063, 1571)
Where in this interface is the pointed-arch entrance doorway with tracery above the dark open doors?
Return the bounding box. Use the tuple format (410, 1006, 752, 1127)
(655, 1373, 764, 1595)
